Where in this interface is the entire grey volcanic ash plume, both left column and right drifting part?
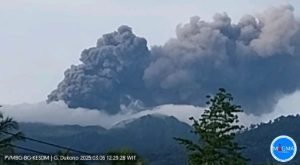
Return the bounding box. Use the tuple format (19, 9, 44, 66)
(48, 6, 300, 115)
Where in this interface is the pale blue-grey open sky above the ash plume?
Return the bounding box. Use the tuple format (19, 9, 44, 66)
(0, 0, 300, 104)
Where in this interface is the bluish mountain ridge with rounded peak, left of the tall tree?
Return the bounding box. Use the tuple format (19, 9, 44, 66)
(20, 115, 193, 165)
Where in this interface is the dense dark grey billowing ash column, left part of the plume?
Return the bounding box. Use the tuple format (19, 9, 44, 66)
(48, 26, 149, 113)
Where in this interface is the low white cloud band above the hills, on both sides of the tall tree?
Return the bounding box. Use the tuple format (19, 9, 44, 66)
(1, 91, 300, 128)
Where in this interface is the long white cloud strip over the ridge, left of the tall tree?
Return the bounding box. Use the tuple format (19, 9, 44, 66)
(1, 102, 202, 128)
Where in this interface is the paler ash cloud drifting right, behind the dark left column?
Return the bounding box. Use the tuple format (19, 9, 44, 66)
(144, 6, 300, 114)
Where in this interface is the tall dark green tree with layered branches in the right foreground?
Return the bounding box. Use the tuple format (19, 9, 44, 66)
(175, 88, 247, 165)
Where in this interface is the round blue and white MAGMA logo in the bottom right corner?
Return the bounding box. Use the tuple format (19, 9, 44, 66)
(270, 135, 297, 162)
